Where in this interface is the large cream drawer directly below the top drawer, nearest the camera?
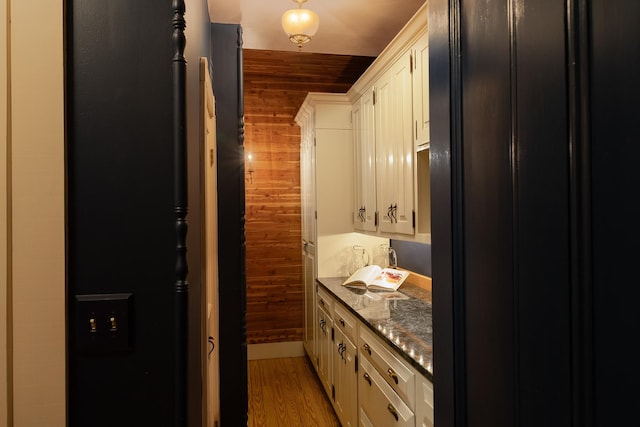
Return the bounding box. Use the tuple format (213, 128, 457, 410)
(358, 358, 415, 427)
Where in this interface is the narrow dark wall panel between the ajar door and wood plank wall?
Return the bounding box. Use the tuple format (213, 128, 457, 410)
(211, 24, 247, 426)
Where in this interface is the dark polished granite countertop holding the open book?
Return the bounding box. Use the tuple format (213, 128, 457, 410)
(317, 277, 433, 382)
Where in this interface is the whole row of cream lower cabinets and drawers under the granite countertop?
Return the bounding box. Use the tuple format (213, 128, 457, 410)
(316, 288, 433, 427)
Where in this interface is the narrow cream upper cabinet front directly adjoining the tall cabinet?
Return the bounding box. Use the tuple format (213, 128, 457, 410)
(353, 90, 377, 231)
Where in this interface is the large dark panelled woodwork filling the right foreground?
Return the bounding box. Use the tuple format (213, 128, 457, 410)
(429, 0, 640, 427)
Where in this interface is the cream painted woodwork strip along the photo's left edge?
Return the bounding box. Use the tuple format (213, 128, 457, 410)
(6, 0, 67, 426)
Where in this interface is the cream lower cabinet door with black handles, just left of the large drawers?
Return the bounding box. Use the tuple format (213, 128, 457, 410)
(333, 326, 358, 427)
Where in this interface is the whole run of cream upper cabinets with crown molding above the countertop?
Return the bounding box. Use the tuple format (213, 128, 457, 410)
(347, 2, 431, 242)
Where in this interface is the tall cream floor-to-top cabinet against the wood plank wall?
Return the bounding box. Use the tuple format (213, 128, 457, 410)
(295, 92, 354, 368)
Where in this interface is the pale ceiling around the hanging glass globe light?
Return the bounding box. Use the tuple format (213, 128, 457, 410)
(207, 0, 426, 56)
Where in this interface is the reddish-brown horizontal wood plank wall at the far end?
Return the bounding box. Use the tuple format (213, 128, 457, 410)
(244, 49, 375, 344)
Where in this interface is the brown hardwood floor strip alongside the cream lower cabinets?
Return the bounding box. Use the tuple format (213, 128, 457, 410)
(248, 357, 340, 427)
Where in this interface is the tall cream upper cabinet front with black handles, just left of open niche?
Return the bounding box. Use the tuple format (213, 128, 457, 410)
(375, 50, 414, 235)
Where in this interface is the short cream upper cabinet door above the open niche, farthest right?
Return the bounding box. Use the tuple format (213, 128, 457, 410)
(412, 33, 430, 147)
